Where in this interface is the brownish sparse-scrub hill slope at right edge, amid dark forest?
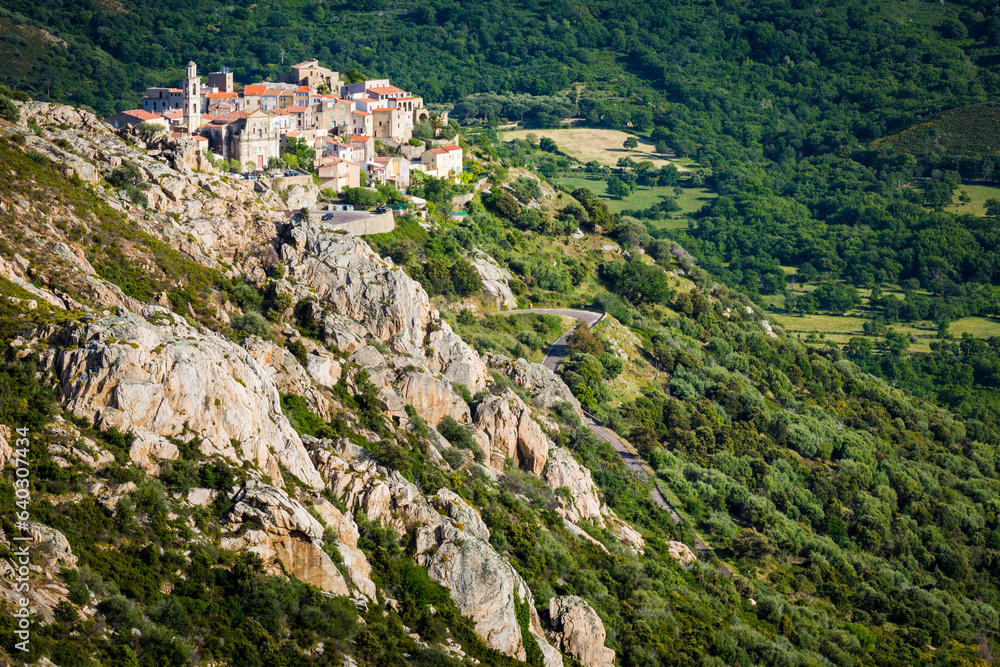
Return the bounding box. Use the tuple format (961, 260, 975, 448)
(873, 102, 1000, 157)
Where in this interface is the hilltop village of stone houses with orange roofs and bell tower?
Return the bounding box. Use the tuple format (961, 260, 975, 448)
(106, 60, 462, 192)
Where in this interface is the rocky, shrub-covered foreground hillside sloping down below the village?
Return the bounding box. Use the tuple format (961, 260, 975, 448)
(0, 102, 1000, 667)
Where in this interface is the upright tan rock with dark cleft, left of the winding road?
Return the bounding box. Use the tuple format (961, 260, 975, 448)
(475, 389, 549, 475)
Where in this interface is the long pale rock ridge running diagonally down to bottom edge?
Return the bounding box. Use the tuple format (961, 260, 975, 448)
(310, 440, 562, 667)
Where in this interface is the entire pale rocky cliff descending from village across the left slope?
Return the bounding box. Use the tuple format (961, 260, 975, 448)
(0, 103, 643, 667)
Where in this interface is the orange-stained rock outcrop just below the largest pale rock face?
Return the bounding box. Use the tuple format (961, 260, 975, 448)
(221, 483, 362, 595)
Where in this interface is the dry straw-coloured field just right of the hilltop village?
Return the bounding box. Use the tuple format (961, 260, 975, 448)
(501, 127, 691, 171)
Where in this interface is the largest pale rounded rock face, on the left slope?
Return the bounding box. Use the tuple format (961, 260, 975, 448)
(35, 306, 322, 488)
